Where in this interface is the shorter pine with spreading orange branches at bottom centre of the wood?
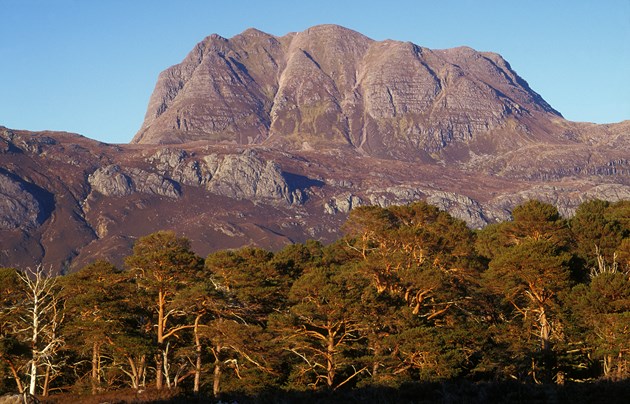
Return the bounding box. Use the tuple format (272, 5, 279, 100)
(274, 266, 371, 389)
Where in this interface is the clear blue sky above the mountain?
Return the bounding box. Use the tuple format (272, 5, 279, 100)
(0, 0, 630, 143)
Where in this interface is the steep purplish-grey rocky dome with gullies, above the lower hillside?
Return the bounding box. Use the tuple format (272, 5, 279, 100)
(133, 25, 560, 160)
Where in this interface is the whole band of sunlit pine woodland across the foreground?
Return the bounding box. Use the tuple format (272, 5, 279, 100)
(0, 200, 630, 403)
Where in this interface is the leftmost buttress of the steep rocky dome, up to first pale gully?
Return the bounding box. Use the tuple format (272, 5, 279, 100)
(133, 30, 283, 144)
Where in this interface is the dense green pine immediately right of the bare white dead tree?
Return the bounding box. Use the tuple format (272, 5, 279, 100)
(61, 261, 152, 393)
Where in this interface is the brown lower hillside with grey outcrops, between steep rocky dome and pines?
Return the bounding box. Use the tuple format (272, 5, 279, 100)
(0, 123, 630, 273)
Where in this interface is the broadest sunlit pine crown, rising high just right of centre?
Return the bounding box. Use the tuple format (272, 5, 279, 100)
(346, 202, 481, 321)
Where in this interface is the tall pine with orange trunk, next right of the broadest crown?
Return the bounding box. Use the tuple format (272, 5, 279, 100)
(477, 201, 571, 382)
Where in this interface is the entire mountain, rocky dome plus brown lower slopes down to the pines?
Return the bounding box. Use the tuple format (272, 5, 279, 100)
(0, 25, 630, 271)
